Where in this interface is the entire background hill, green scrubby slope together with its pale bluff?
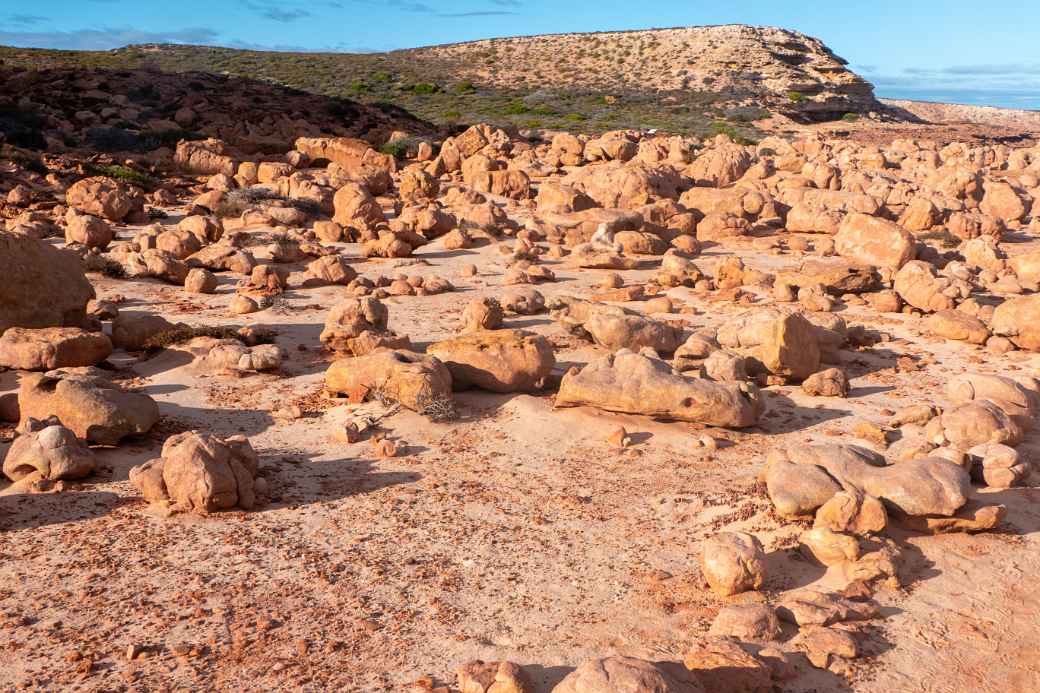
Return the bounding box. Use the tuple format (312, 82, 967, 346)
(0, 25, 885, 138)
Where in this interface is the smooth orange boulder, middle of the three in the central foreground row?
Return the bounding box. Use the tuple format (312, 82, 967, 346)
(426, 330, 556, 392)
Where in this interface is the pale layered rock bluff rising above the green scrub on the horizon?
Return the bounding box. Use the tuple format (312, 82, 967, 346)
(406, 25, 883, 120)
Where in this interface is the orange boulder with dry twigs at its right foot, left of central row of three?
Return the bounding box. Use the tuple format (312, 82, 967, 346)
(324, 350, 451, 412)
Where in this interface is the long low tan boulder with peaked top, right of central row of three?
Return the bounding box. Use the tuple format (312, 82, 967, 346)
(555, 350, 763, 428)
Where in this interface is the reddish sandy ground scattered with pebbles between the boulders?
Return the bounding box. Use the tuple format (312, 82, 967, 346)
(0, 195, 1040, 693)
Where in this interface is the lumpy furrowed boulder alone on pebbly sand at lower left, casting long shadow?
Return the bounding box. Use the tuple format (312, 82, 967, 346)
(130, 431, 261, 513)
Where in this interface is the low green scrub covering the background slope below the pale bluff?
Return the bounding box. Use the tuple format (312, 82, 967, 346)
(0, 46, 769, 139)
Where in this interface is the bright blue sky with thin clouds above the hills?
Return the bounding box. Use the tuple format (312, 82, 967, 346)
(0, 0, 1040, 108)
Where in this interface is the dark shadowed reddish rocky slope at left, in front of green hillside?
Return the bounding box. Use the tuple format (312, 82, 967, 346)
(0, 67, 435, 153)
